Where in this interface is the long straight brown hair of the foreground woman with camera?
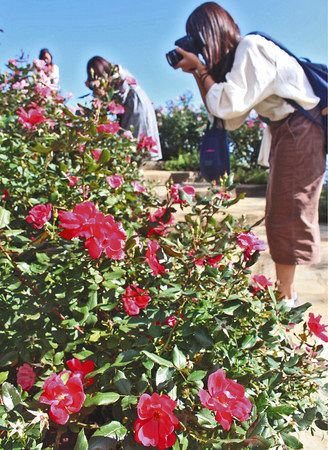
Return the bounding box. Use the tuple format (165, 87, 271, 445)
(186, 2, 240, 83)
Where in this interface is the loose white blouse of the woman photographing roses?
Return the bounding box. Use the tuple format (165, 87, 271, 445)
(206, 35, 319, 165)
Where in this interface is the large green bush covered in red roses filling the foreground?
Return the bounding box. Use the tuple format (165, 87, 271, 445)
(0, 61, 326, 450)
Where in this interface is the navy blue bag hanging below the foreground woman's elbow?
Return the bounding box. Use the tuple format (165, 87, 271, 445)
(199, 118, 230, 181)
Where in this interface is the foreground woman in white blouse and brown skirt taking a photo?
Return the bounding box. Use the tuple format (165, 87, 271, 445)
(175, 2, 325, 306)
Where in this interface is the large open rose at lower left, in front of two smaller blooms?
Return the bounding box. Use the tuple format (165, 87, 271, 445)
(40, 371, 85, 425)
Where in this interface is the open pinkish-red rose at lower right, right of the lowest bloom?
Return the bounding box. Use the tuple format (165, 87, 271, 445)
(198, 369, 252, 431)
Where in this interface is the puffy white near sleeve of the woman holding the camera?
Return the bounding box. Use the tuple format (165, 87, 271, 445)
(206, 35, 277, 129)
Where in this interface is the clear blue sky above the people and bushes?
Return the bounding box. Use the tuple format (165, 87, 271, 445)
(0, 0, 328, 105)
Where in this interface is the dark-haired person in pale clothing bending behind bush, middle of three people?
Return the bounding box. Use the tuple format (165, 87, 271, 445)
(85, 56, 162, 160)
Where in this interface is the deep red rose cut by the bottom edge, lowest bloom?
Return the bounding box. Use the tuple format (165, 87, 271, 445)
(134, 393, 179, 450)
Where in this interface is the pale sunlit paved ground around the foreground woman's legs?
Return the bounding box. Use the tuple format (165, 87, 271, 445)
(144, 170, 328, 450)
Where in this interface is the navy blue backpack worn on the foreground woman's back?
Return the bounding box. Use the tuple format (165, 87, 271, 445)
(249, 31, 328, 149)
